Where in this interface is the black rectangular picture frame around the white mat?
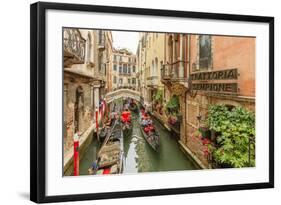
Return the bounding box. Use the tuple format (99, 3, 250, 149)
(30, 2, 274, 203)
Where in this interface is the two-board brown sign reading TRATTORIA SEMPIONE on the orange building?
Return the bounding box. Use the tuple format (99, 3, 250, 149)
(190, 68, 238, 93)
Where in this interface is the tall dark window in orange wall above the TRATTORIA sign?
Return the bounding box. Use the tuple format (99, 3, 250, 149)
(199, 35, 212, 70)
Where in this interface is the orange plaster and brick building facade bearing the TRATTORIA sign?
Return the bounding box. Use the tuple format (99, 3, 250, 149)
(181, 35, 255, 167)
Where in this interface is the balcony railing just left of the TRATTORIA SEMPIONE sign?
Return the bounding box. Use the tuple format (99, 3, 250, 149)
(161, 61, 187, 81)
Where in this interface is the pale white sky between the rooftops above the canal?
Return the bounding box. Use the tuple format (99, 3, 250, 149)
(112, 31, 139, 54)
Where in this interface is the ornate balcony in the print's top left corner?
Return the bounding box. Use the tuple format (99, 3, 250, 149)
(63, 29, 86, 67)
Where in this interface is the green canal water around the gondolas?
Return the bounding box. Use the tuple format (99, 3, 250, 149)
(77, 102, 198, 175)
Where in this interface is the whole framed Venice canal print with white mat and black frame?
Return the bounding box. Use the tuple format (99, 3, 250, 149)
(30, 2, 274, 203)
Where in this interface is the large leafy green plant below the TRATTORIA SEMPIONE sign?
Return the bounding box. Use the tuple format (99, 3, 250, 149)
(207, 105, 255, 167)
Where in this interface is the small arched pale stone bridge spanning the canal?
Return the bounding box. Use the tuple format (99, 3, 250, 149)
(105, 88, 140, 103)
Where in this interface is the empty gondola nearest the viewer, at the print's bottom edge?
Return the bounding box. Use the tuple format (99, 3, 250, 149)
(88, 122, 124, 175)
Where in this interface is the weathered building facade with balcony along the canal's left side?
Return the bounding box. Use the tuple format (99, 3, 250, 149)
(63, 29, 112, 150)
